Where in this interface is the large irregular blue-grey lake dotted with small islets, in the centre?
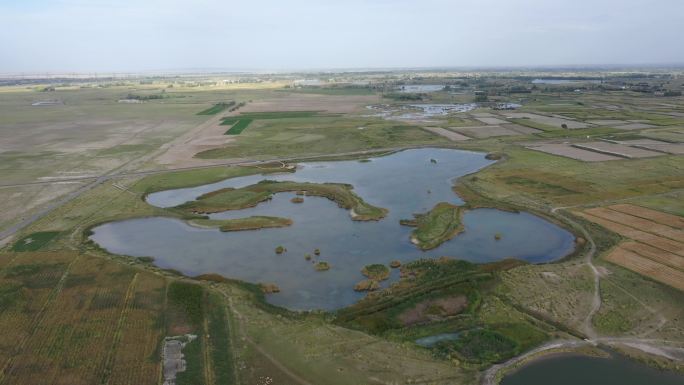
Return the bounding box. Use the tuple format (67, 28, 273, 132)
(91, 148, 574, 310)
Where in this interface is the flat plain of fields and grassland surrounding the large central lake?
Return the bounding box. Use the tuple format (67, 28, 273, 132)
(0, 72, 684, 385)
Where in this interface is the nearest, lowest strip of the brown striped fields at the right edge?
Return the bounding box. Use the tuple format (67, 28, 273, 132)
(606, 247, 684, 290)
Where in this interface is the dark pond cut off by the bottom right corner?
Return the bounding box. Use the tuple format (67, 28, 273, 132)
(501, 354, 684, 385)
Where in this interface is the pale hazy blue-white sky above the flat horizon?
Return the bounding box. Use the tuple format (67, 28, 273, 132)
(0, 0, 684, 73)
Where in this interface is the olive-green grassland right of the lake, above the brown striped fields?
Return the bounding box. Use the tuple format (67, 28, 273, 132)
(454, 146, 684, 206)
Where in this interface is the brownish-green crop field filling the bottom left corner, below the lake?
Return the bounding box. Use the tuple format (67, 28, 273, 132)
(0, 252, 240, 384)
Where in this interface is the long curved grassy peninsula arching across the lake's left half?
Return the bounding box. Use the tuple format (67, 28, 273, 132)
(177, 180, 387, 221)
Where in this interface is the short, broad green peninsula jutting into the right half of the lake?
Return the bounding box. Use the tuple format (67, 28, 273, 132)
(400, 202, 463, 250)
